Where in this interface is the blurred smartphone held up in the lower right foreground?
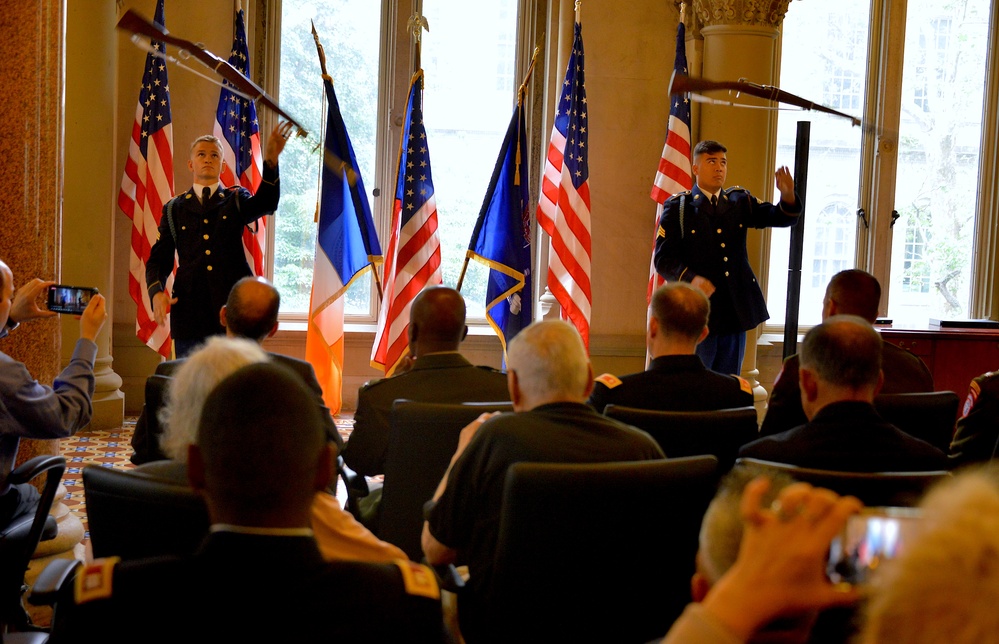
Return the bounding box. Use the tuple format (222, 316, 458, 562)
(826, 508, 922, 584)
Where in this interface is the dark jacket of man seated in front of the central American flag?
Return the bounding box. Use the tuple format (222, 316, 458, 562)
(343, 353, 510, 476)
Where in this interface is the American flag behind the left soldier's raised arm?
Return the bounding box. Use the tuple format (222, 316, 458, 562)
(213, 9, 267, 275)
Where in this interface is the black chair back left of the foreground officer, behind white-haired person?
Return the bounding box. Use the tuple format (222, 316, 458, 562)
(83, 466, 211, 559)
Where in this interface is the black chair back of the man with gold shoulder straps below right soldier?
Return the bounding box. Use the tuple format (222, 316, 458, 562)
(604, 405, 759, 473)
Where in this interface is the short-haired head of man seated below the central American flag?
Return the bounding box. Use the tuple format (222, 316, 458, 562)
(409, 286, 468, 357)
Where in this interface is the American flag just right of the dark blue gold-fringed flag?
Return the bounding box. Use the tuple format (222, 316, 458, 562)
(538, 22, 592, 348)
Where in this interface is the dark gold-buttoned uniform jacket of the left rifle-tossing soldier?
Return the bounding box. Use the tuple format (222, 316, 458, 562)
(146, 163, 280, 340)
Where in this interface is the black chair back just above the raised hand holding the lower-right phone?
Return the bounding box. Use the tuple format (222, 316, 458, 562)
(735, 458, 951, 507)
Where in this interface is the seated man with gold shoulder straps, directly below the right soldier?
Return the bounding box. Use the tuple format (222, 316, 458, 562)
(589, 282, 753, 412)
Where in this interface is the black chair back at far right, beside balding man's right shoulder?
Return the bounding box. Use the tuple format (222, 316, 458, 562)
(874, 391, 960, 454)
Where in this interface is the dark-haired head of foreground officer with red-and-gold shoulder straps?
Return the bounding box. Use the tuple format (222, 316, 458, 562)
(190, 362, 330, 526)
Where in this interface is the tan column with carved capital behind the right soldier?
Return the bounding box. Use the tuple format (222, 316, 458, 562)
(692, 0, 790, 409)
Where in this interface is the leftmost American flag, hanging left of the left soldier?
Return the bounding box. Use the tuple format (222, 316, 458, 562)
(118, 0, 173, 358)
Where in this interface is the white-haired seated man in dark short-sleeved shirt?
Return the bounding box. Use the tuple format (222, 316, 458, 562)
(422, 321, 663, 642)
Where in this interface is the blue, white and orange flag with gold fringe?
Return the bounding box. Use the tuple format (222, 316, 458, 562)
(305, 71, 382, 414)
